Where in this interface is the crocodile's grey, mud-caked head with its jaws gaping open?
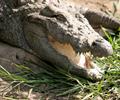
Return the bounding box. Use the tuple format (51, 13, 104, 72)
(24, 6, 113, 80)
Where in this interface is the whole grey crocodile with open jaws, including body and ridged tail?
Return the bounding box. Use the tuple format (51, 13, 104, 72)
(0, 0, 120, 80)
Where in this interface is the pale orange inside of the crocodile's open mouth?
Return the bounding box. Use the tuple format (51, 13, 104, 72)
(48, 36, 95, 69)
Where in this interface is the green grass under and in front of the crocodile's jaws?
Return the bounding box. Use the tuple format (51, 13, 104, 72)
(0, 29, 120, 100)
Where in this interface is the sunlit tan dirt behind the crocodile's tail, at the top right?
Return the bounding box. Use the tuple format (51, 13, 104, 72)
(68, 0, 120, 17)
